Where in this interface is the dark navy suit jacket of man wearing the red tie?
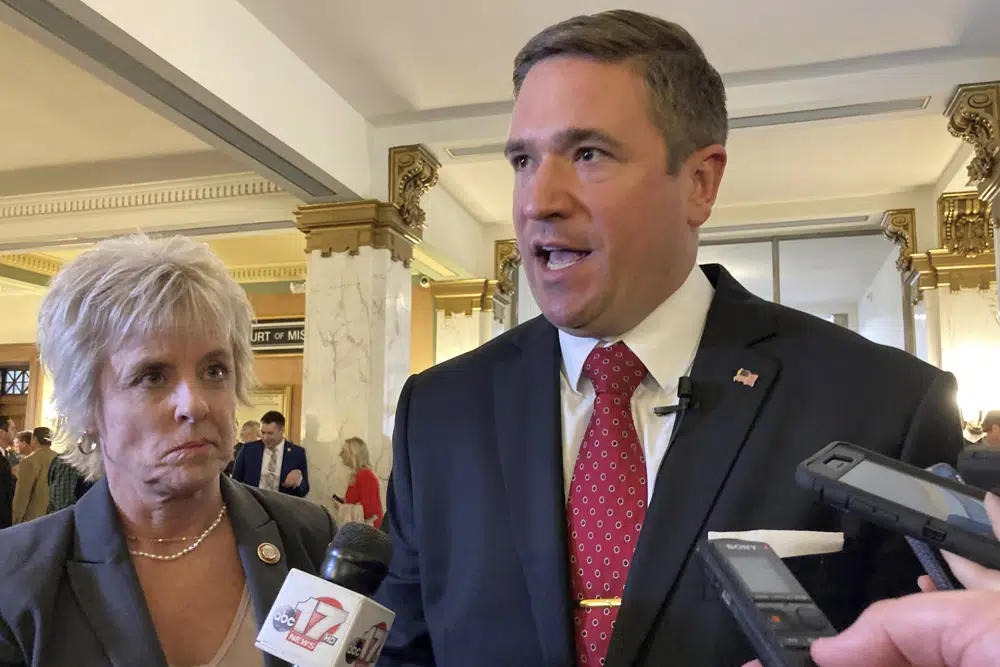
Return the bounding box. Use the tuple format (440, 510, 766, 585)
(376, 265, 962, 667)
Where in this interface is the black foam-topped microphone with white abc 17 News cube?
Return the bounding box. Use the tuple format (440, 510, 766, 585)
(255, 523, 396, 667)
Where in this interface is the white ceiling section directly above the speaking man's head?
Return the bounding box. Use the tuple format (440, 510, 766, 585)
(241, 0, 1000, 118)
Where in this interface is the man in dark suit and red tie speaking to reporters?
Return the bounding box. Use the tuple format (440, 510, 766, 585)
(377, 11, 962, 667)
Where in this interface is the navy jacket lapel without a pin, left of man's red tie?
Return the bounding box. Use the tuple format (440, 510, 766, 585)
(494, 318, 573, 665)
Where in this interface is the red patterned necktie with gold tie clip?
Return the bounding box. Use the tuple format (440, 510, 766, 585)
(567, 343, 646, 665)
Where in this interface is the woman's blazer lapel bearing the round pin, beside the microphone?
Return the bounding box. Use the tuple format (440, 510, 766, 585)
(222, 477, 288, 667)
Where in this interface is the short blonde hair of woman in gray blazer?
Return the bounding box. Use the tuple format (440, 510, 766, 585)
(38, 234, 255, 481)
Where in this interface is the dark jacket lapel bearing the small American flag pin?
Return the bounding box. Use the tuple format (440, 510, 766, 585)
(607, 271, 780, 667)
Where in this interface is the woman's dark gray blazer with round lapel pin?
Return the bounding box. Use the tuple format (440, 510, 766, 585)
(0, 476, 336, 667)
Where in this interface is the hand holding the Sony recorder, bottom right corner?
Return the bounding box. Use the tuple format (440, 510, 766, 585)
(812, 591, 1000, 667)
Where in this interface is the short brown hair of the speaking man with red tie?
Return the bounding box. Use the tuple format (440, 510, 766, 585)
(514, 9, 729, 174)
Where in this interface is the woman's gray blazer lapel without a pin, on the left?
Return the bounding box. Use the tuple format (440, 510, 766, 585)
(66, 478, 167, 667)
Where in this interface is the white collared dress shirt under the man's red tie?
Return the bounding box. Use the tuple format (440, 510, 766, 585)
(559, 265, 715, 502)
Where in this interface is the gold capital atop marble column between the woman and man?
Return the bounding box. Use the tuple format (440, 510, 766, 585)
(295, 199, 421, 268)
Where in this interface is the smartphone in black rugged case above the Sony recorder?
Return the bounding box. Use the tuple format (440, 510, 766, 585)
(795, 442, 1000, 568)
